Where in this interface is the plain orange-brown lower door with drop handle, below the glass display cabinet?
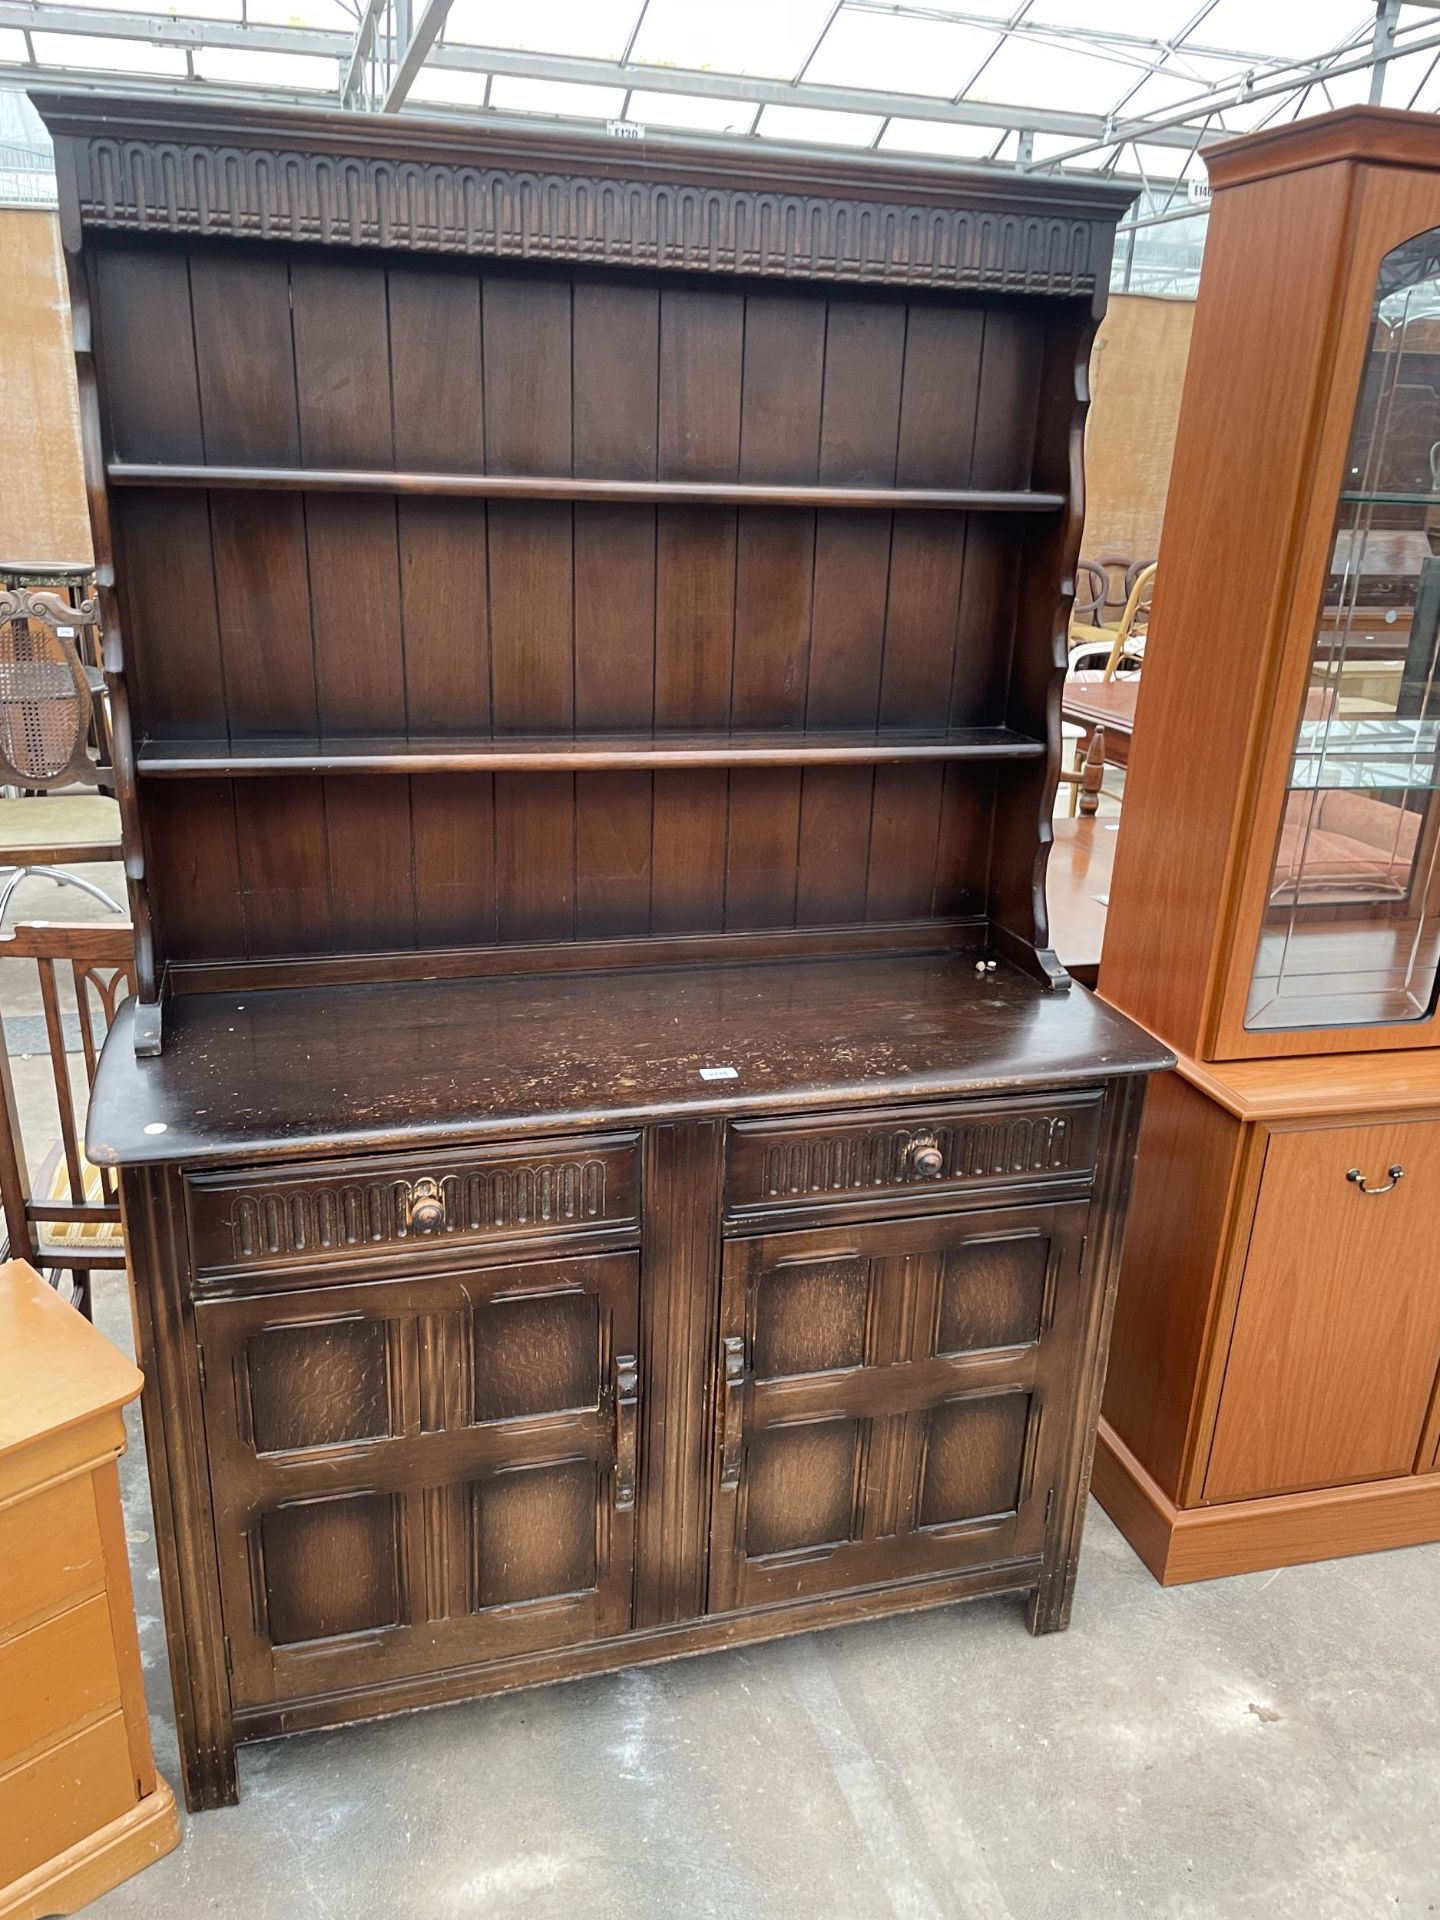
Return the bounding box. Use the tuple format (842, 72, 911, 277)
(1206, 1121, 1440, 1500)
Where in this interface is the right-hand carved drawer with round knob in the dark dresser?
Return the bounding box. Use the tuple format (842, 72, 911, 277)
(726, 1091, 1100, 1219)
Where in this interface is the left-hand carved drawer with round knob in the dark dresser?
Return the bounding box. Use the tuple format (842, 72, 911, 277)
(186, 1133, 639, 1275)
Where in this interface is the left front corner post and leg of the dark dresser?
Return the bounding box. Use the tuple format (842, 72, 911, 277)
(121, 1167, 240, 1812)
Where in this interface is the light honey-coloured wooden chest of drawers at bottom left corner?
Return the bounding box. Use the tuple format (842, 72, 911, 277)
(0, 1260, 180, 1920)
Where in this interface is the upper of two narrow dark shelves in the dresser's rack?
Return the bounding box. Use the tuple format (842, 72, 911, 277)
(106, 461, 1066, 513)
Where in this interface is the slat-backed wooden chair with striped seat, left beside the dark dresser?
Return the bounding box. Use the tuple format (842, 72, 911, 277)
(0, 922, 134, 1319)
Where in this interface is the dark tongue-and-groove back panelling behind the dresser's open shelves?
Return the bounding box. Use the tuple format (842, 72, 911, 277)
(88, 238, 1089, 964)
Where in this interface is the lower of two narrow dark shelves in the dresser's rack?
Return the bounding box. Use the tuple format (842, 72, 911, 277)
(136, 726, 1044, 778)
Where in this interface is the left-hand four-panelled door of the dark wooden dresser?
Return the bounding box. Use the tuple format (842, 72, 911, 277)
(196, 1254, 637, 1707)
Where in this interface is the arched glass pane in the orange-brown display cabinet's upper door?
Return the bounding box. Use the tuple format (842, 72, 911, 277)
(1246, 228, 1440, 1033)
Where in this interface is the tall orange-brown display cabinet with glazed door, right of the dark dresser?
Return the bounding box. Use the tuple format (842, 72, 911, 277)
(1096, 109, 1440, 1582)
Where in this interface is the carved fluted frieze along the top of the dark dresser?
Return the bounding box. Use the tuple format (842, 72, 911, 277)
(75, 134, 1110, 296)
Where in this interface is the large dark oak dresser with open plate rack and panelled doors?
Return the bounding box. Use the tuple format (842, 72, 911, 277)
(40, 98, 1169, 1807)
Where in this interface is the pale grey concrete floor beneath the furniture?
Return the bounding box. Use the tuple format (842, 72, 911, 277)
(11, 803, 1440, 1920)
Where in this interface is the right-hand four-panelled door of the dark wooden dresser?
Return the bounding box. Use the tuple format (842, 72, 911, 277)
(710, 1204, 1087, 1613)
